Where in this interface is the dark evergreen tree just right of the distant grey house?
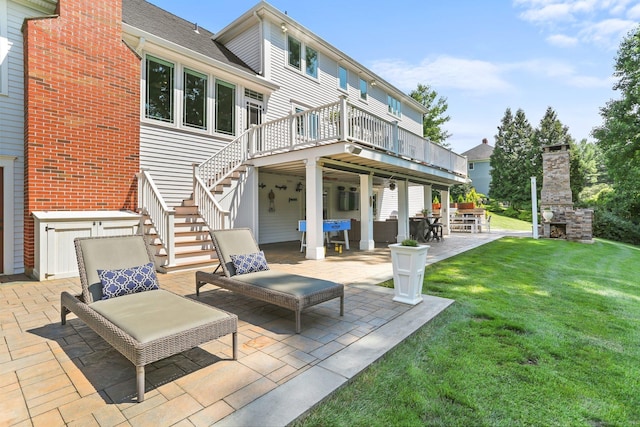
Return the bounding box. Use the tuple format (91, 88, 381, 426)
(489, 108, 534, 208)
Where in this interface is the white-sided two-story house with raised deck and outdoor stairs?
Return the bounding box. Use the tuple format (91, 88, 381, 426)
(0, 0, 467, 280)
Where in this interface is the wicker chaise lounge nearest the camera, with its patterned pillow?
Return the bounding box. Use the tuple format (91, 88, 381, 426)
(60, 235, 238, 402)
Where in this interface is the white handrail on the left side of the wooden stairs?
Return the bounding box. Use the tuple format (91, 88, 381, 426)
(138, 169, 176, 266)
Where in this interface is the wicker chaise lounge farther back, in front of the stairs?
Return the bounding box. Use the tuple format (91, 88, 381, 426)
(196, 228, 344, 333)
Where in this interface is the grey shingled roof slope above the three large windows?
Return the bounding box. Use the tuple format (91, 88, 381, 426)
(122, 0, 256, 74)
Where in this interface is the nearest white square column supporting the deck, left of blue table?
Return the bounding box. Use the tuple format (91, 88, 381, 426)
(305, 157, 325, 259)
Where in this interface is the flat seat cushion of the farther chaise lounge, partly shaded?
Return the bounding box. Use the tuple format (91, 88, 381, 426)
(233, 270, 342, 298)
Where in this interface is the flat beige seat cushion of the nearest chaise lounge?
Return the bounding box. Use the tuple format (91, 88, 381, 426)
(90, 289, 229, 344)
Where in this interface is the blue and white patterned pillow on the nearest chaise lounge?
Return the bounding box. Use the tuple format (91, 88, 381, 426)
(98, 262, 158, 299)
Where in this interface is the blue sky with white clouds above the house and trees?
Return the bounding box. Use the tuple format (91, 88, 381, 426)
(150, 0, 640, 153)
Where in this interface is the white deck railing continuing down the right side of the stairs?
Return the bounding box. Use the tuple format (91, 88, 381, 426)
(193, 97, 467, 232)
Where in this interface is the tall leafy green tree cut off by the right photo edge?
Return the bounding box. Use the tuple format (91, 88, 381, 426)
(593, 25, 640, 224)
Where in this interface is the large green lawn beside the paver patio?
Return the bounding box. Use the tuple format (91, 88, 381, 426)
(297, 239, 640, 426)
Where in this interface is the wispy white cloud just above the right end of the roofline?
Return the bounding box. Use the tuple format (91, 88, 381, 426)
(371, 56, 513, 93)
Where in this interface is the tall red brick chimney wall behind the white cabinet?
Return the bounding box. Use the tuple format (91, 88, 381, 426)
(23, 0, 141, 271)
